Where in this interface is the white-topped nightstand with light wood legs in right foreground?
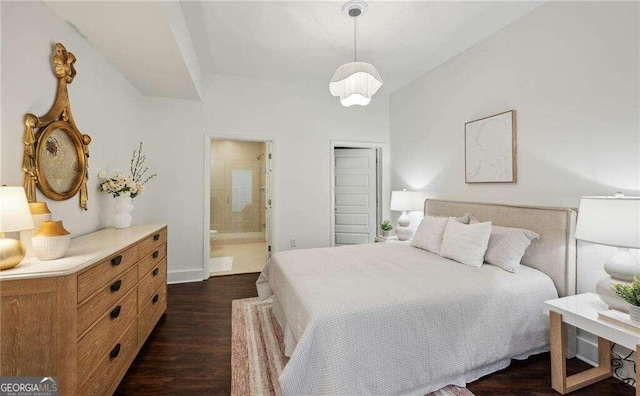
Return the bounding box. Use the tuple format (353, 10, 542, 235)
(544, 293, 640, 396)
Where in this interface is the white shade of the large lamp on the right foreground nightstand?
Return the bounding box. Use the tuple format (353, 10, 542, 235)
(576, 197, 640, 249)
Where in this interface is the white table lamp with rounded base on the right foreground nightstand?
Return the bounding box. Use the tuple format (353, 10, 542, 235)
(575, 193, 640, 312)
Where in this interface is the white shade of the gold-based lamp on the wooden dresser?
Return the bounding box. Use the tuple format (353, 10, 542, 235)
(0, 186, 33, 232)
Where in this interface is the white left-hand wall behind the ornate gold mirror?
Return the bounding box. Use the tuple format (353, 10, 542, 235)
(0, 2, 143, 236)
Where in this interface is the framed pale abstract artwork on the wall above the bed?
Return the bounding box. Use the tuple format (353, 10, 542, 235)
(464, 110, 517, 183)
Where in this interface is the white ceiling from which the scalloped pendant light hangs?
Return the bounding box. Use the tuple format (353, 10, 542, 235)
(49, 1, 541, 99)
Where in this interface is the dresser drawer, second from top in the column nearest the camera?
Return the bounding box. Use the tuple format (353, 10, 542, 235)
(77, 265, 138, 336)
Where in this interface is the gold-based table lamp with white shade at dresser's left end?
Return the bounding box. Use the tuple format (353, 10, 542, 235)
(0, 186, 33, 270)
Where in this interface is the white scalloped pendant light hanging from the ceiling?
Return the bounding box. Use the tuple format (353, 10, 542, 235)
(329, 0, 382, 107)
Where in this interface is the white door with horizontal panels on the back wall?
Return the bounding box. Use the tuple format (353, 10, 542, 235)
(333, 148, 378, 246)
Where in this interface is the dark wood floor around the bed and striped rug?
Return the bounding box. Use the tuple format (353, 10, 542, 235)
(116, 274, 634, 396)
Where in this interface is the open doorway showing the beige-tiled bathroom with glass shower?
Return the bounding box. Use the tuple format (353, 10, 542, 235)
(207, 139, 272, 276)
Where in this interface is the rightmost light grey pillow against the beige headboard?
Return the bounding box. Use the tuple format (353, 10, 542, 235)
(484, 226, 540, 272)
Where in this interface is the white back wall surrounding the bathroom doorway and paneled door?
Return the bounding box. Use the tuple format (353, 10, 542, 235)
(144, 77, 389, 282)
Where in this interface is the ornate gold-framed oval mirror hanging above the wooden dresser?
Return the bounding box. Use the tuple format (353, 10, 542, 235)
(22, 43, 91, 210)
